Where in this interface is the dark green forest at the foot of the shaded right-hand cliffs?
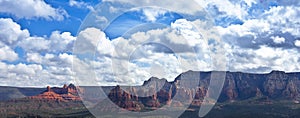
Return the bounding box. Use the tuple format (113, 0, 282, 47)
(181, 101, 300, 118)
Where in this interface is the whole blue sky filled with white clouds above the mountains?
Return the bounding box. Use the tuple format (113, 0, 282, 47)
(0, 0, 300, 87)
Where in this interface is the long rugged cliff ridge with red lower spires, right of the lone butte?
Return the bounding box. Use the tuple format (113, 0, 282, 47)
(108, 71, 300, 110)
